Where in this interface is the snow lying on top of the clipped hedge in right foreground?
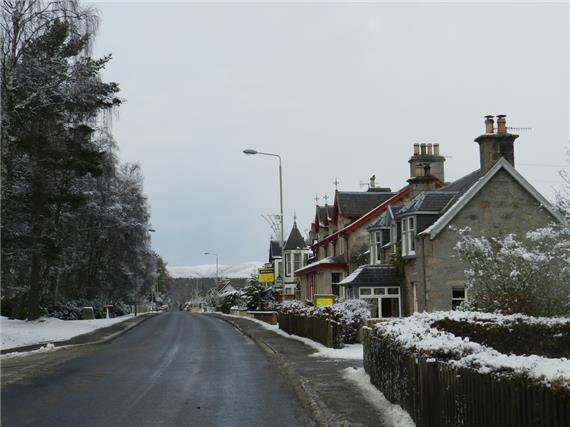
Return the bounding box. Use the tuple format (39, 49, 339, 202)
(374, 311, 570, 388)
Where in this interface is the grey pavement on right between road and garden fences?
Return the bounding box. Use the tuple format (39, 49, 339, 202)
(209, 314, 394, 427)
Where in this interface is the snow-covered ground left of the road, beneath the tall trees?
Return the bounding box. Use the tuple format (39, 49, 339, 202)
(0, 314, 133, 350)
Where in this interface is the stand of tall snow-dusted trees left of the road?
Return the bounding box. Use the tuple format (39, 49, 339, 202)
(0, 0, 157, 319)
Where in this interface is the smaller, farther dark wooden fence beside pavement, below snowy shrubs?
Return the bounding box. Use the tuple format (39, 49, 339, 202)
(277, 313, 343, 348)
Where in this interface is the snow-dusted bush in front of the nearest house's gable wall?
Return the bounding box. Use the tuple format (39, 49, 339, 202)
(455, 224, 570, 316)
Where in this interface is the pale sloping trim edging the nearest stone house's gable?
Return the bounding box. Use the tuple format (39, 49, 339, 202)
(420, 158, 563, 239)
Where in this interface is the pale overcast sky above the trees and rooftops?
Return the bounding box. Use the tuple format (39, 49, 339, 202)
(94, 2, 569, 266)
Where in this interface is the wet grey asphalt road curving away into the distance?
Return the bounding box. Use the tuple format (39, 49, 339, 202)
(1, 312, 311, 427)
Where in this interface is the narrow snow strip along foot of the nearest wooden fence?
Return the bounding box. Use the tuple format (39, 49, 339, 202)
(341, 368, 416, 427)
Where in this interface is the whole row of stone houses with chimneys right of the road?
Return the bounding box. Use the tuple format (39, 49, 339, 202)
(269, 115, 562, 318)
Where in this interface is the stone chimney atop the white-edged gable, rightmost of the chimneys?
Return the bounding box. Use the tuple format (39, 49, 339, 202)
(475, 114, 519, 174)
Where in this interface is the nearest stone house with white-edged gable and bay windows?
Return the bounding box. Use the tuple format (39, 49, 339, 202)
(341, 115, 562, 317)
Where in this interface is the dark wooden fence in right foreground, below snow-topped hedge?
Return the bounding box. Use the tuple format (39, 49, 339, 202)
(364, 329, 570, 427)
